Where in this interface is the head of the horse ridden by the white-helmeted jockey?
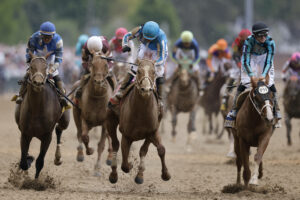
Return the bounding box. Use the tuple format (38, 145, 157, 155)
(90, 53, 108, 87)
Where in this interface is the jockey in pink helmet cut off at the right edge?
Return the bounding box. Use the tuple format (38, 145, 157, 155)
(281, 52, 300, 82)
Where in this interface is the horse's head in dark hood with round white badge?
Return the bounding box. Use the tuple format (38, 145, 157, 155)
(251, 81, 274, 123)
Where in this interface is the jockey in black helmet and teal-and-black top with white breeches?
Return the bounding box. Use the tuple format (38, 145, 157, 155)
(225, 22, 281, 128)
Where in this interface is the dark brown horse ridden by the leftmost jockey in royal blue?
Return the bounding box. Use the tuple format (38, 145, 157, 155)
(15, 54, 70, 178)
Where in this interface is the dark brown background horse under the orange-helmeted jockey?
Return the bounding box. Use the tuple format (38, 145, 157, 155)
(200, 70, 226, 134)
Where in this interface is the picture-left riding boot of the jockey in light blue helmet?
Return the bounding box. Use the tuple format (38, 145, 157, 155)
(108, 73, 134, 107)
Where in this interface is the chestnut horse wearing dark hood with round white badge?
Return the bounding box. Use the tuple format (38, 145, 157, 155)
(232, 81, 274, 186)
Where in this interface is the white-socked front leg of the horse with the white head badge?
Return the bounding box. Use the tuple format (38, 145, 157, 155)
(249, 133, 271, 185)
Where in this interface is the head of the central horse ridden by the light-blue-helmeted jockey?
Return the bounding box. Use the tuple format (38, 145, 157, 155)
(136, 59, 155, 96)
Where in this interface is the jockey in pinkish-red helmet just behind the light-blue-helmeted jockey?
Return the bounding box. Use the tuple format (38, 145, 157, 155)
(109, 27, 134, 62)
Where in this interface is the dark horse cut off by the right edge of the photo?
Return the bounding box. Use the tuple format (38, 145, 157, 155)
(283, 75, 300, 145)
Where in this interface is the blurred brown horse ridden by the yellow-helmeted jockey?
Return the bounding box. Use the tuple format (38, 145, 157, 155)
(167, 59, 199, 144)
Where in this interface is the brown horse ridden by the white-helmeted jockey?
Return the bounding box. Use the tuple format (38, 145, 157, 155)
(73, 53, 113, 175)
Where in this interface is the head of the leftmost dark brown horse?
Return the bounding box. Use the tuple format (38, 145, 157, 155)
(29, 52, 50, 92)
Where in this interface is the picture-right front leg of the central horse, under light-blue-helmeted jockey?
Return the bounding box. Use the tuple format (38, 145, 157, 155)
(151, 131, 171, 181)
